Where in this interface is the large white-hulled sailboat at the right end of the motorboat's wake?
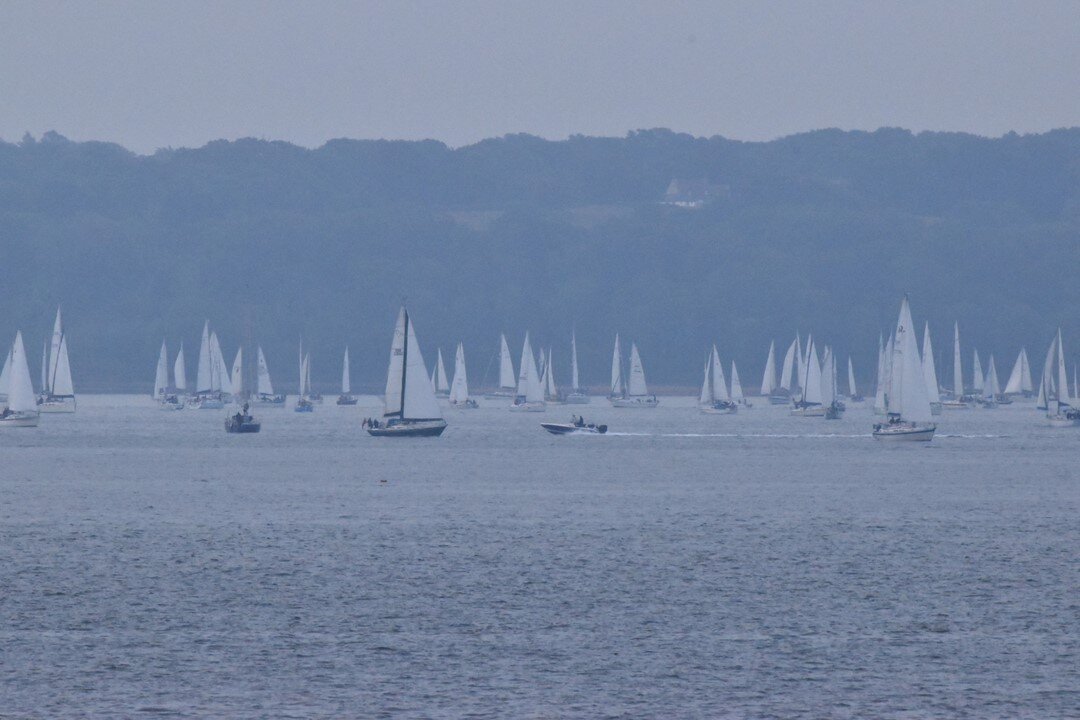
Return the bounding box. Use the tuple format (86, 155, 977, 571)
(874, 295, 937, 441)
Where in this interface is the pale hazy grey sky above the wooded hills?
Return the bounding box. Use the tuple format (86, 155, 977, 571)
(0, 0, 1080, 152)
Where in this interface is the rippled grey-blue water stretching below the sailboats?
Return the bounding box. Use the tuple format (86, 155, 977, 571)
(0, 396, 1080, 718)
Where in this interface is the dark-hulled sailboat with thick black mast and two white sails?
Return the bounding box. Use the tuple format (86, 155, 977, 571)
(364, 307, 444, 437)
